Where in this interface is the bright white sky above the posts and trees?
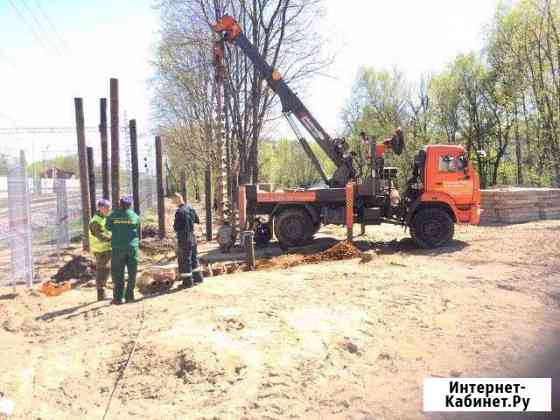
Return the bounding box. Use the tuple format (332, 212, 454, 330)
(0, 0, 504, 164)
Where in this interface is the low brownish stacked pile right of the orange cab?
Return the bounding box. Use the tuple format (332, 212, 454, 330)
(481, 188, 560, 223)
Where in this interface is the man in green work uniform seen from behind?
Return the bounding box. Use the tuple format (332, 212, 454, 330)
(107, 197, 140, 305)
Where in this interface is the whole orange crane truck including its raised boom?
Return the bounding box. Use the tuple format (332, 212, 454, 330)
(213, 15, 480, 248)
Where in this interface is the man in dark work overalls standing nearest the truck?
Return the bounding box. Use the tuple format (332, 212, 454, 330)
(173, 193, 203, 288)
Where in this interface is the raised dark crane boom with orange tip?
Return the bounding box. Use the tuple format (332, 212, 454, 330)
(212, 15, 355, 187)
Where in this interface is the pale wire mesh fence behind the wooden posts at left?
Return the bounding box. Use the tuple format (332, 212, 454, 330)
(0, 148, 157, 287)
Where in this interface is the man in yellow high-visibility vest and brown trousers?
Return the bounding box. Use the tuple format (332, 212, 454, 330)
(89, 199, 111, 301)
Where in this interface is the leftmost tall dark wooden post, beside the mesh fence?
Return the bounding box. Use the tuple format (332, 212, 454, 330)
(74, 98, 91, 251)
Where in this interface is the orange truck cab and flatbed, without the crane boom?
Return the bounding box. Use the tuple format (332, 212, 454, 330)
(238, 145, 480, 246)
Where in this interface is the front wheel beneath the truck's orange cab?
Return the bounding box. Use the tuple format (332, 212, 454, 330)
(410, 207, 455, 248)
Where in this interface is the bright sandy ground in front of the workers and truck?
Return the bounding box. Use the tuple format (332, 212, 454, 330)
(0, 221, 560, 420)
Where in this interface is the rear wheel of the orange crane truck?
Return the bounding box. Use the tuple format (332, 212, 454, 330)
(274, 209, 313, 247)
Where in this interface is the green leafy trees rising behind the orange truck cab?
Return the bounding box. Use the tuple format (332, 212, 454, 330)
(344, 0, 560, 187)
